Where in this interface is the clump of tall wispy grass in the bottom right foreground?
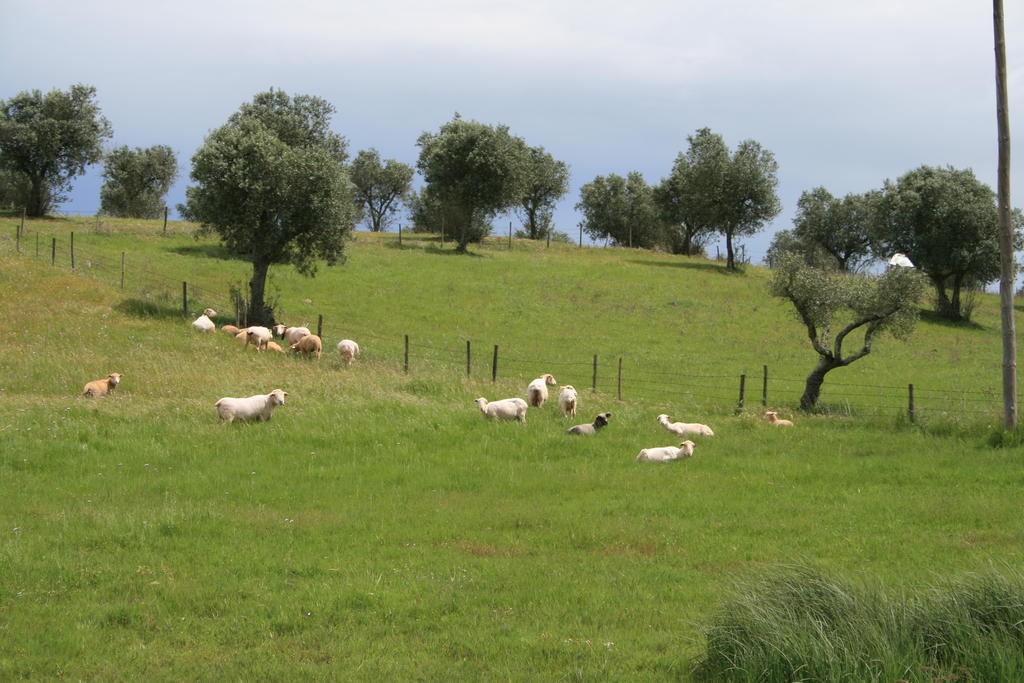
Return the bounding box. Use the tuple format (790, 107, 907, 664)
(694, 566, 1024, 681)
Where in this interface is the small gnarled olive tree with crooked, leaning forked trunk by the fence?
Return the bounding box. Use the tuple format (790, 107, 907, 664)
(769, 254, 926, 411)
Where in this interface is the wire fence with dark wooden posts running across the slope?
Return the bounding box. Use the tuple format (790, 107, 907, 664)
(2, 223, 1002, 422)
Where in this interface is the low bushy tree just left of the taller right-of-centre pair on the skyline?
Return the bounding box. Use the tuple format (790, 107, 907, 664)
(575, 171, 662, 249)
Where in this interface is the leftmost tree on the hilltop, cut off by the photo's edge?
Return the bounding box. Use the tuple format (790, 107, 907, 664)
(0, 84, 113, 216)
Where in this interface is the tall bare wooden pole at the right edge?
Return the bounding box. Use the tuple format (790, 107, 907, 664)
(992, 0, 1018, 429)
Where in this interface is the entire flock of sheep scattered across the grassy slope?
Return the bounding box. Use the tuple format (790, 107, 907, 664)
(81, 308, 793, 450)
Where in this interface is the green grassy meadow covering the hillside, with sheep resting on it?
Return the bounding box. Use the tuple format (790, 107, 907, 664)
(0, 218, 1024, 680)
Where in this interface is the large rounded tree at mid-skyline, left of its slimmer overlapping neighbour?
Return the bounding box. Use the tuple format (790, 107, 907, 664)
(417, 115, 528, 251)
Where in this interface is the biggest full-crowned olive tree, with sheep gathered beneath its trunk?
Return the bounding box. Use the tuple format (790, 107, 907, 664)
(180, 90, 356, 324)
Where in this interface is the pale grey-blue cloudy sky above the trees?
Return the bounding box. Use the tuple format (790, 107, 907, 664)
(0, 0, 1024, 262)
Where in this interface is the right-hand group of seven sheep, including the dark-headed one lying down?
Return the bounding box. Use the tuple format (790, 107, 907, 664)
(476, 374, 793, 463)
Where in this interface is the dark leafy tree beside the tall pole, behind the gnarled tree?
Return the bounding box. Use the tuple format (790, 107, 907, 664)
(872, 166, 999, 321)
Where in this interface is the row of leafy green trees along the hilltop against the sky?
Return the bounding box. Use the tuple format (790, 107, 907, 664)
(0, 85, 1022, 319)
